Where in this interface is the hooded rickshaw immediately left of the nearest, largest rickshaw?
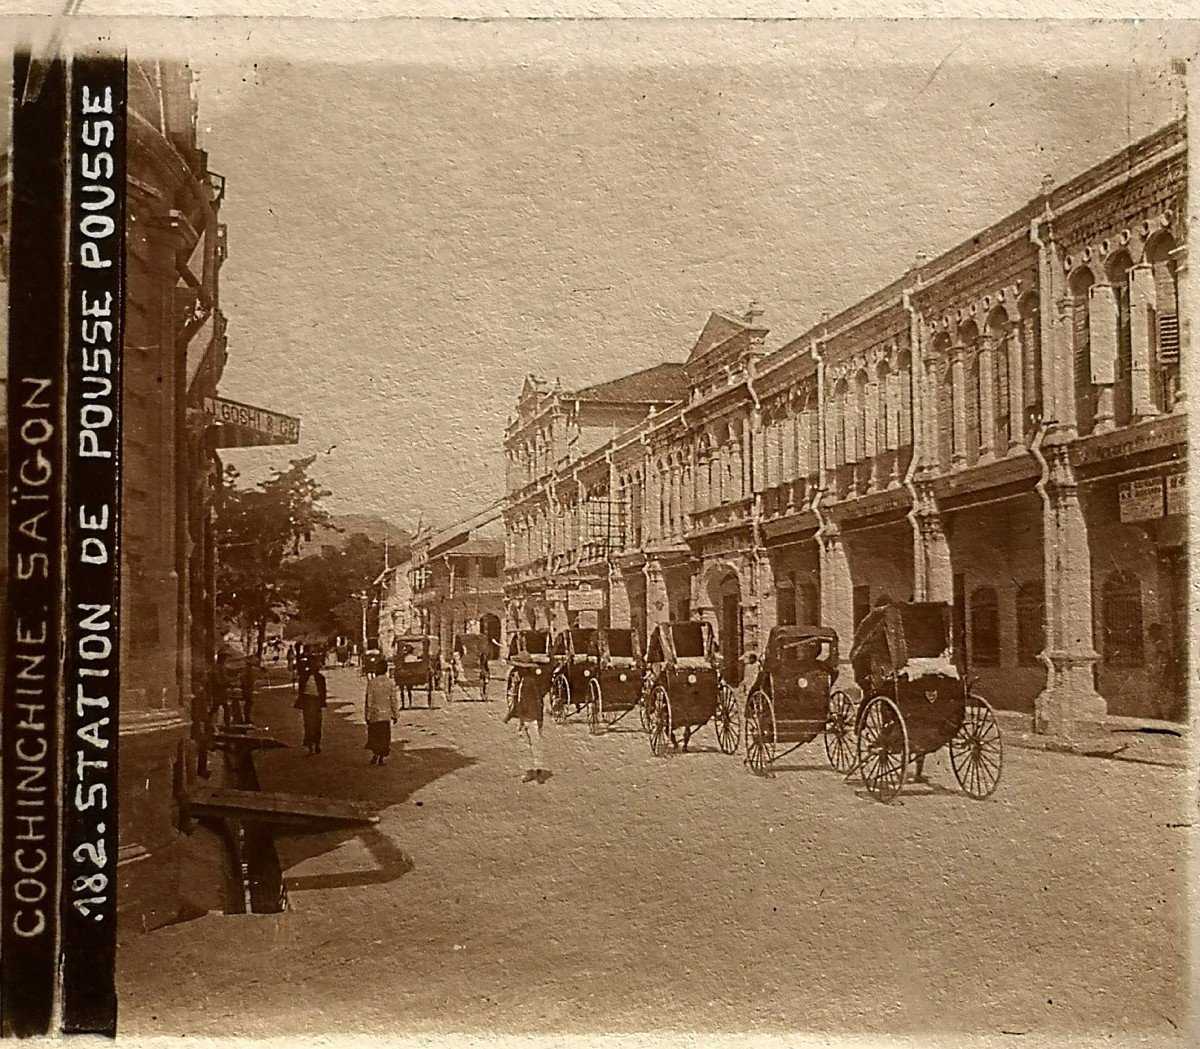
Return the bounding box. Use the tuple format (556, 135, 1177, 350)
(744, 627, 857, 775)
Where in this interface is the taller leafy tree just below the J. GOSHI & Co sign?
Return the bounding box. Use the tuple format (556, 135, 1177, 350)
(216, 456, 331, 655)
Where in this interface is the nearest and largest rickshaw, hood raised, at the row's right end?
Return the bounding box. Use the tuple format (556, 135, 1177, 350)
(850, 601, 1004, 802)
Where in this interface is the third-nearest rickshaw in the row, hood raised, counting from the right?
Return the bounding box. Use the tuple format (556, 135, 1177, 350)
(644, 622, 742, 756)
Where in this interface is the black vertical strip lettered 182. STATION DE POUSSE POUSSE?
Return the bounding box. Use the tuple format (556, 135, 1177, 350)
(62, 56, 126, 1036)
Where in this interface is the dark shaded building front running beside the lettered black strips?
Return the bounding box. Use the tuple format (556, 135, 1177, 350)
(0, 62, 226, 930)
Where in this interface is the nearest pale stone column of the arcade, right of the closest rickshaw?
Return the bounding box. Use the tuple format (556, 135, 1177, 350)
(1033, 444, 1106, 736)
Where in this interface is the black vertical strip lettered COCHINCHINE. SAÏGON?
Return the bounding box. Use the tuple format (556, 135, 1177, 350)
(0, 54, 67, 1036)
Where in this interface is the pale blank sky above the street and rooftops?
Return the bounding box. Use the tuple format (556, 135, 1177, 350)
(175, 22, 1180, 525)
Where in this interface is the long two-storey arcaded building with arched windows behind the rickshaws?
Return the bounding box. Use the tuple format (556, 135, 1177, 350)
(505, 121, 1189, 732)
